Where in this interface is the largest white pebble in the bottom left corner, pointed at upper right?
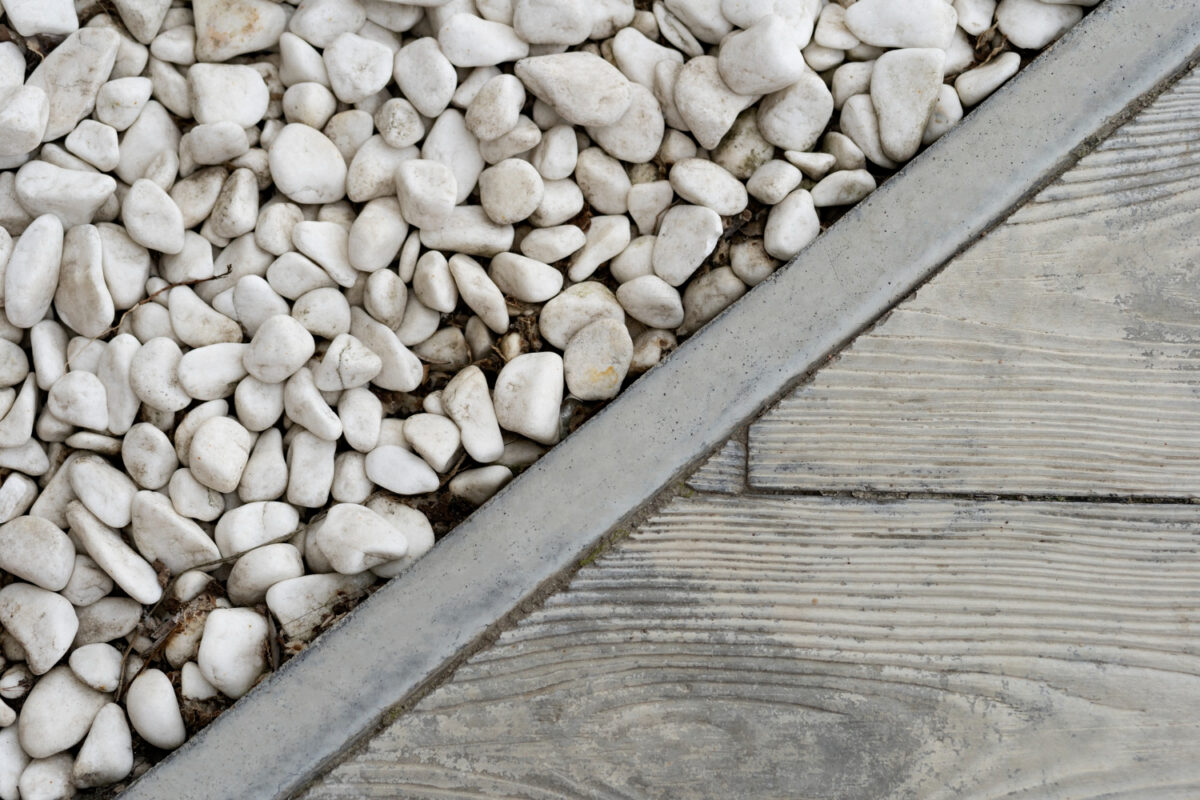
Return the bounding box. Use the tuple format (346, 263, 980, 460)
(17, 666, 109, 758)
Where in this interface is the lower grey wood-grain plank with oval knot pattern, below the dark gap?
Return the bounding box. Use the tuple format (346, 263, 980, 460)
(302, 494, 1200, 800)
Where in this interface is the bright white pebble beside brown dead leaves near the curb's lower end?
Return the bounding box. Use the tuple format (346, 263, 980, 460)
(197, 608, 269, 698)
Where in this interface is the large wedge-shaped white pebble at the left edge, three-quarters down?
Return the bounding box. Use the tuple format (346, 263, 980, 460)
(0, 583, 79, 675)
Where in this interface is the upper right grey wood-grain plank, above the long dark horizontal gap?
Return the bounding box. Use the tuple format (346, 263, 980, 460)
(749, 70, 1200, 498)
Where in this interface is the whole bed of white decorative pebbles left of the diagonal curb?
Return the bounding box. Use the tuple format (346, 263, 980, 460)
(0, 0, 1097, 800)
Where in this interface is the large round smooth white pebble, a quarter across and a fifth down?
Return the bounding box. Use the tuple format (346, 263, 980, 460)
(268, 122, 347, 203)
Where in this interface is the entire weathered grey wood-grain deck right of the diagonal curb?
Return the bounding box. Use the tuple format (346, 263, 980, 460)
(300, 59, 1200, 800)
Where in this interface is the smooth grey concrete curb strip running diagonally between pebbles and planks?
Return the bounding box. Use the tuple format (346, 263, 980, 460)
(122, 0, 1200, 800)
